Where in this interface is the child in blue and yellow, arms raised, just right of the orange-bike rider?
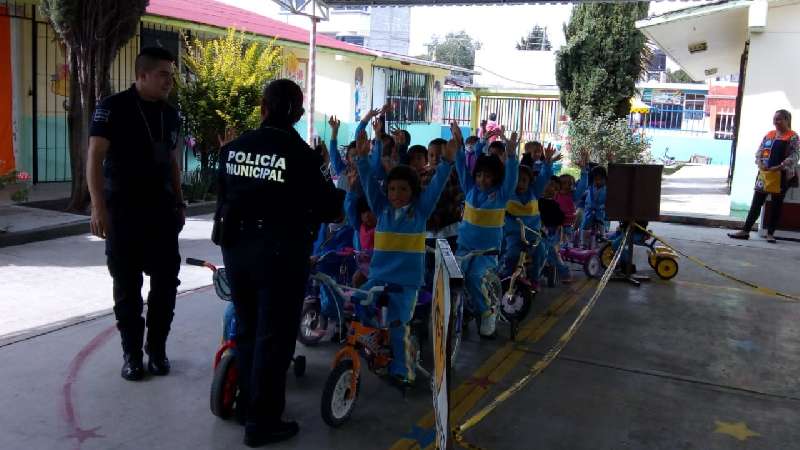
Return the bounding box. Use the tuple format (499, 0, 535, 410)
(454, 130, 519, 338)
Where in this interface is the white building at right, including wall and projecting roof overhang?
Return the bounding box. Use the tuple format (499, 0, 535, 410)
(637, 0, 800, 223)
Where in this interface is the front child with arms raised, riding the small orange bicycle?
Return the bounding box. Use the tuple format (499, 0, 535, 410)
(356, 129, 456, 384)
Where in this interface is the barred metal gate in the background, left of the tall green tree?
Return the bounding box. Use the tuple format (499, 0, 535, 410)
(480, 97, 564, 142)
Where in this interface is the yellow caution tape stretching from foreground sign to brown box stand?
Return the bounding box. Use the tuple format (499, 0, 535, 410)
(453, 229, 630, 450)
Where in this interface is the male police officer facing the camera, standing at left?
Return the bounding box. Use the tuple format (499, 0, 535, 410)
(87, 48, 185, 381)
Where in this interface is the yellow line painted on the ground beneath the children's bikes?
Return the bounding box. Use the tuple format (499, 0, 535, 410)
(390, 279, 593, 450)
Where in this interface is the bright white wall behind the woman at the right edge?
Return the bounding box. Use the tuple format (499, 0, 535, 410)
(731, 4, 800, 210)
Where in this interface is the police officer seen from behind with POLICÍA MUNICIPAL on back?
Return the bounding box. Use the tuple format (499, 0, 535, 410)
(214, 80, 344, 447)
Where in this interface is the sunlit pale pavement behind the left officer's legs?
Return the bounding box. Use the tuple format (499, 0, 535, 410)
(0, 216, 222, 342)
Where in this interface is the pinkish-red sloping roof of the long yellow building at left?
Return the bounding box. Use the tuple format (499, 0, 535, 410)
(147, 0, 377, 56)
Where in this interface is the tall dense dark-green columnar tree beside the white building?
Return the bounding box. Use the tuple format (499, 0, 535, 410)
(556, 2, 651, 164)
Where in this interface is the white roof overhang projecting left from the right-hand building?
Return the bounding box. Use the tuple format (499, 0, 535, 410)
(636, 0, 752, 80)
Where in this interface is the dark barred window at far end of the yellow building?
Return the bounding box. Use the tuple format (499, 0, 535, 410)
(372, 67, 433, 123)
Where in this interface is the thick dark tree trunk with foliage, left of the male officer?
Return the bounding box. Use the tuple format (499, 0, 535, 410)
(41, 0, 149, 211)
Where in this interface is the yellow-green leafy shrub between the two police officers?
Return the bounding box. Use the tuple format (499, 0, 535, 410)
(178, 29, 284, 170)
